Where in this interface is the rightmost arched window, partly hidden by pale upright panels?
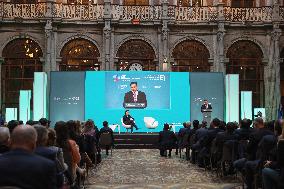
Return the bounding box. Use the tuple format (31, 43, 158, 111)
(226, 40, 264, 107)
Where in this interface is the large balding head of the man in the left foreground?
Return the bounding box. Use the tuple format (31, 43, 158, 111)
(11, 125, 37, 152)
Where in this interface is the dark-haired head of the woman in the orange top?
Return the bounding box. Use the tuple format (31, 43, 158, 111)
(54, 121, 69, 148)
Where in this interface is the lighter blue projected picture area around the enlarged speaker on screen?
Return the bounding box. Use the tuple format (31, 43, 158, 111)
(105, 72, 170, 110)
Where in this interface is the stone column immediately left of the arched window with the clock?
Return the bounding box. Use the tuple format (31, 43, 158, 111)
(101, 0, 114, 70)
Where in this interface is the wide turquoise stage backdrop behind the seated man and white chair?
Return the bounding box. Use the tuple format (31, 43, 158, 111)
(85, 71, 190, 132)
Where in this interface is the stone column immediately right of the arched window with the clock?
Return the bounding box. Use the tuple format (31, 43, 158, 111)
(159, 0, 170, 71)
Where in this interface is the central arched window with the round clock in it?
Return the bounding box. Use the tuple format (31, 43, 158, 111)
(116, 39, 156, 71)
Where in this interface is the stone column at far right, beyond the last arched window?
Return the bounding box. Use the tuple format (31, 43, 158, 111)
(264, 24, 281, 120)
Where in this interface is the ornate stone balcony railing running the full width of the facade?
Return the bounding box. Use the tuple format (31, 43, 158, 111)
(0, 2, 284, 23)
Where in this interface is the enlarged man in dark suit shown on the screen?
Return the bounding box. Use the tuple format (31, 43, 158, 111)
(123, 82, 147, 108)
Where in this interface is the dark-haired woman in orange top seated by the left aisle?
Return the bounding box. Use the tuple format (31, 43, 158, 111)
(54, 121, 84, 188)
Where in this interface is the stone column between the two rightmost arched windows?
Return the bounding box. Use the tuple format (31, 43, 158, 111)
(212, 3, 225, 73)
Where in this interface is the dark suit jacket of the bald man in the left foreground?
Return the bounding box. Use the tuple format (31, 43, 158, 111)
(0, 149, 56, 189)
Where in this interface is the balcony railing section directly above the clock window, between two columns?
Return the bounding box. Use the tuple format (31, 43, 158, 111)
(111, 5, 162, 21)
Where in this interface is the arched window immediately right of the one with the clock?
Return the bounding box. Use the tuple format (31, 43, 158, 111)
(172, 40, 210, 72)
